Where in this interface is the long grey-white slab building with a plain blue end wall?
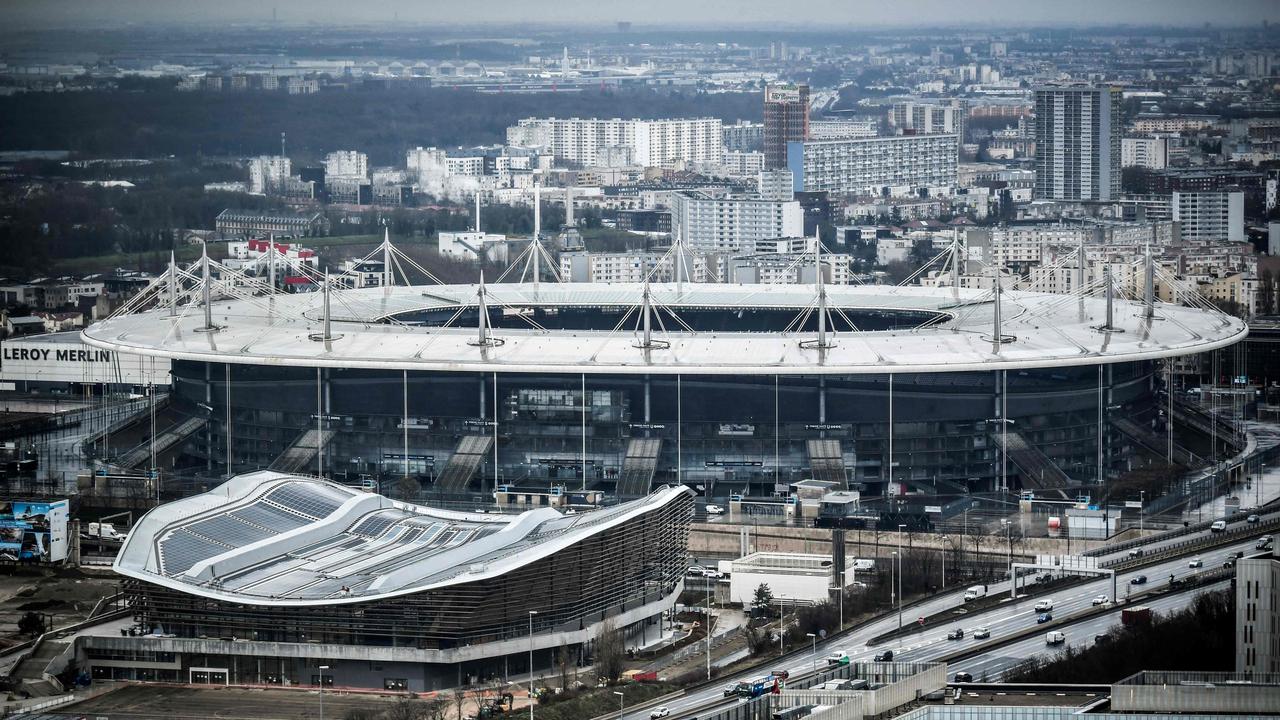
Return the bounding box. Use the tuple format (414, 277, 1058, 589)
(787, 135, 959, 196)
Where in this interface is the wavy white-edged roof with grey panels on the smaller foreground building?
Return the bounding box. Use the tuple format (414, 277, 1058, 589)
(115, 470, 692, 606)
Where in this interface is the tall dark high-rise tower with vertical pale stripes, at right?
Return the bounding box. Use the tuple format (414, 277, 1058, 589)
(1036, 85, 1121, 200)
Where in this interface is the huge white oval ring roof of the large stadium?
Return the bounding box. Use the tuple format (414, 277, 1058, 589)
(83, 283, 1247, 374)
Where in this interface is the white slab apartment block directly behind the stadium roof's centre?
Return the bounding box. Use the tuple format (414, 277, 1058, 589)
(671, 191, 804, 252)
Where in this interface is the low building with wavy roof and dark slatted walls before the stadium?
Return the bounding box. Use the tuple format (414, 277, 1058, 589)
(96, 470, 692, 692)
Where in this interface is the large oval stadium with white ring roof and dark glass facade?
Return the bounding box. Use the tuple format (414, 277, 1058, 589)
(74, 248, 1247, 506)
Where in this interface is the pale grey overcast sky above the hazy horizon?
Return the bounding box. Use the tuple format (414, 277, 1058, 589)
(0, 0, 1280, 29)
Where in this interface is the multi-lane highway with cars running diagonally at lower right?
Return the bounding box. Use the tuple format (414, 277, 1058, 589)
(625, 512, 1275, 720)
